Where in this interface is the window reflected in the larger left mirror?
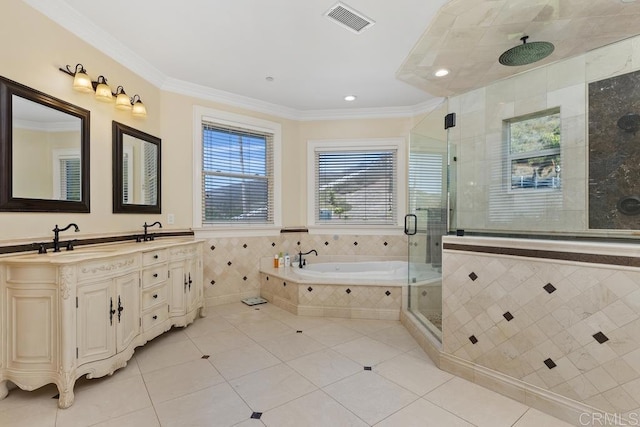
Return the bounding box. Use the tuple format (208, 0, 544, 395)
(53, 149, 82, 201)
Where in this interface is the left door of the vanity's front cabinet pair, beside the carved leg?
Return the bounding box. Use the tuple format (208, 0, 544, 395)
(76, 279, 118, 365)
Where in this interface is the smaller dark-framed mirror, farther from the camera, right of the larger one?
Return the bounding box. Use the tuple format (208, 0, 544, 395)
(112, 121, 161, 213)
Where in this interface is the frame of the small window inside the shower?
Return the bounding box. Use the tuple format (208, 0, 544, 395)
(503, 107, 563, 194)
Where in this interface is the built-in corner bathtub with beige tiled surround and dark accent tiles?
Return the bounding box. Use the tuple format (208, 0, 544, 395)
(260, 256, 416, 320)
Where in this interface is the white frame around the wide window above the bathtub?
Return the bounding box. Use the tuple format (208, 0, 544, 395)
(307, 137, 407, 235)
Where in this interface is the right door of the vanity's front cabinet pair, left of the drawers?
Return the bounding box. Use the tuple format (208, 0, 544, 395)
(114, 271, 140, 352)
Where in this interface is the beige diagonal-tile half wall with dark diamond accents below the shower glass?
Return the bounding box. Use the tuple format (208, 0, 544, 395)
(443, 246, 640, 414)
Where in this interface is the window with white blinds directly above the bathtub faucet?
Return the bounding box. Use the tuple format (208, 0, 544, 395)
(309, 140, 404, 226)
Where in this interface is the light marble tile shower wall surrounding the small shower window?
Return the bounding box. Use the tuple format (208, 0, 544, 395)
(448, 33, 640, 232)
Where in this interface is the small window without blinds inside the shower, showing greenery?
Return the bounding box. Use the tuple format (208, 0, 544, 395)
(507, 109, 562, 190)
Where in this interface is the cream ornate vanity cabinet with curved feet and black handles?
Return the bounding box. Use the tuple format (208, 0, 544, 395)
(0, 240, 205, 408)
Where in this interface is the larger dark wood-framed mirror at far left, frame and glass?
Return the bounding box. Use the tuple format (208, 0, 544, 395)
(0, 77, 90, 212)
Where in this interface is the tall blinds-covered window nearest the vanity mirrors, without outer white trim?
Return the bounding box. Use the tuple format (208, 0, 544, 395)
(202, 121, 274, 224)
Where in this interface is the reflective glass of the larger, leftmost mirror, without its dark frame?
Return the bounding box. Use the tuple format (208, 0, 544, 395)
(12, 95, 82, 201)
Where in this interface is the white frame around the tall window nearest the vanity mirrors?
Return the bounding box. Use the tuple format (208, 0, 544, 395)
(193, 106, 282, 237)
